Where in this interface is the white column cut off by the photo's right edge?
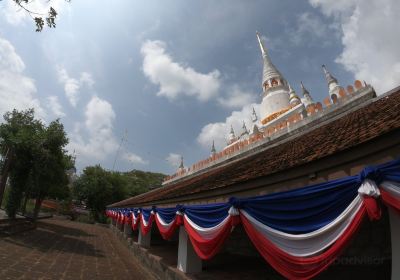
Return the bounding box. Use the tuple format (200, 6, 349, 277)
(388, 207, 400, 280)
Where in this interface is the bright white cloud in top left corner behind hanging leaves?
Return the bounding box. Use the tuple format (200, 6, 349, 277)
(1, 0, 68, 26)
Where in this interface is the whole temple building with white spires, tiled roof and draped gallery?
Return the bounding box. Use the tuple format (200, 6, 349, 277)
(107, 32, 400, 279)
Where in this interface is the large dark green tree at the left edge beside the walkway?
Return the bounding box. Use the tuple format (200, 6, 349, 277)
(0, 109, 73, 217)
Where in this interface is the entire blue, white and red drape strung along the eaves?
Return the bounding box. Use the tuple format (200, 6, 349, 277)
(107, 160, 400, 279)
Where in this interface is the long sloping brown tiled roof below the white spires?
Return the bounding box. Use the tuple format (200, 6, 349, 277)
(112, 87, 400, 207)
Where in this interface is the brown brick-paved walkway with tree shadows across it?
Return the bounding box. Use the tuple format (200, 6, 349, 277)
(0, 219, 155, 280)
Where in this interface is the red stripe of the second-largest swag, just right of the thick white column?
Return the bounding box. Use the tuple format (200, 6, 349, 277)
(183, 217, 232, 260)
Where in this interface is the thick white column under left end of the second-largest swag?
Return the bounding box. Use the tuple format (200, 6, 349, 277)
(177, 226, 202, 273)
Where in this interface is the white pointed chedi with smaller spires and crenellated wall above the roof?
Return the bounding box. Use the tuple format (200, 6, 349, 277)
(159, 32, 376, 184)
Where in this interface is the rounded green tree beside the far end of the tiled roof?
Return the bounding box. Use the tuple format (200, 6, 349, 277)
(73, 165, 127, 222)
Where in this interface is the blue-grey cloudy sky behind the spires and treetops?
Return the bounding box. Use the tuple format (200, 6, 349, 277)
(0, 0, 400, 173)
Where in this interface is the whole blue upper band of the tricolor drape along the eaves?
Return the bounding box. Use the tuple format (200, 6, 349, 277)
(111, 159, 400, 234)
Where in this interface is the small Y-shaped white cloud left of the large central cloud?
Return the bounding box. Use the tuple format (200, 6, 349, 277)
(57, 67, 94, 107)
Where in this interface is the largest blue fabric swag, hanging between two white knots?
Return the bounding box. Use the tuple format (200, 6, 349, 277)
(239, 177, 360, 233)
